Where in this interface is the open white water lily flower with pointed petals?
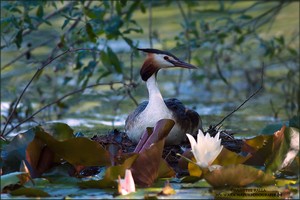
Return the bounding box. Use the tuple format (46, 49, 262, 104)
(186, 130, 223, 168)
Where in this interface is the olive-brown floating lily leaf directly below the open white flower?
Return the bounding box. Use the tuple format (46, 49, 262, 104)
(204, 164, 274, 187)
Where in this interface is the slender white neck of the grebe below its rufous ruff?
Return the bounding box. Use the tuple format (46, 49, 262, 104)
(146, 74, 167, 109)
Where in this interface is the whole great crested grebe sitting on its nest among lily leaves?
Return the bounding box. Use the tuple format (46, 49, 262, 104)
(125, 49, 202, 144)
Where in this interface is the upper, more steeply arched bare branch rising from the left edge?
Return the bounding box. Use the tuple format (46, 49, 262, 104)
(1, 48, 101, 135)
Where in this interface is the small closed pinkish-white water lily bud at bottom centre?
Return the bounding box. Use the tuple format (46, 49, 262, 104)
(118, 169, 135, 195)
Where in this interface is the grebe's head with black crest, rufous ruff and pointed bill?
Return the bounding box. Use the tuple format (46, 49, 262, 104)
(138, 49, 197, 81)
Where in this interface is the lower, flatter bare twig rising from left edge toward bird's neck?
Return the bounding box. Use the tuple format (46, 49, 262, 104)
(3, 82, 122, 137)
